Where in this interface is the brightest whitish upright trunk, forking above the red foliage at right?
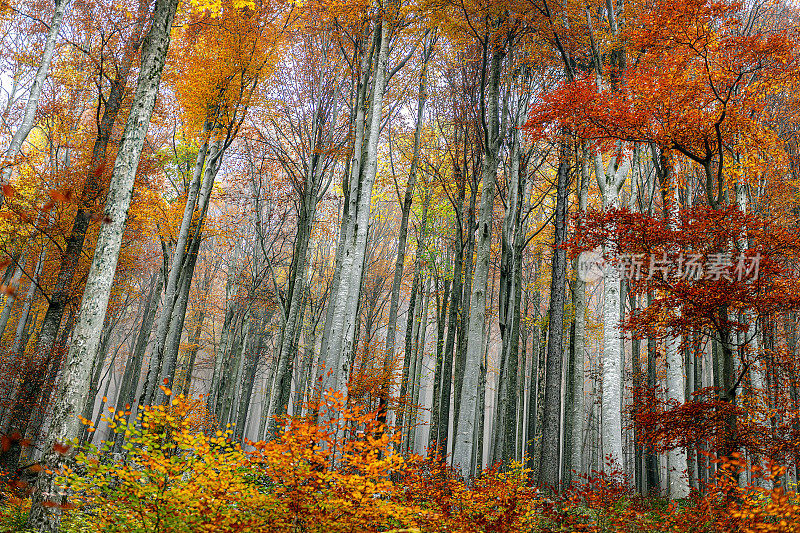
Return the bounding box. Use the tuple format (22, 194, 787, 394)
(594, 144, 630, 469)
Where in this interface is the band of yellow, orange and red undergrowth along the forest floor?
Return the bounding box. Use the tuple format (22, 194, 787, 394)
(0, 393, 800, 533)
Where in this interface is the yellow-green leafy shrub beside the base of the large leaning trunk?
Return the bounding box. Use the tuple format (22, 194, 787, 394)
(62, 388, 272, 532)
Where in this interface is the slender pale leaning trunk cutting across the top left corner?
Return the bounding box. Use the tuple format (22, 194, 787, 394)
(0, 0, 70, 195)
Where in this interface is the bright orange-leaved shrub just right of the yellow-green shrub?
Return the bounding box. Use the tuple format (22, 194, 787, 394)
(251, 393, 418, 533)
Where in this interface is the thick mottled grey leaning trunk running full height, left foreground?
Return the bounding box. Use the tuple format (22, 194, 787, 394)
(28, 0, 178, 533)
